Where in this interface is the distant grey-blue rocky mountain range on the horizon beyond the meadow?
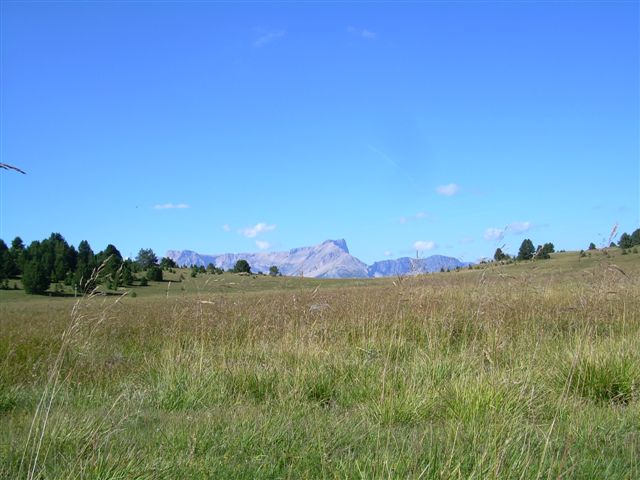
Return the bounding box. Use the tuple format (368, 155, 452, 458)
(166, 239, 469, 278)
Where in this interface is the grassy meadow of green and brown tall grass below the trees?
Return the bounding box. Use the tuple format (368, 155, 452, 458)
(0, 249, 640, 479)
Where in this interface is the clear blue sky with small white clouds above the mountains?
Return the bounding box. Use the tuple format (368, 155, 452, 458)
(0, 1, 640, 262)
